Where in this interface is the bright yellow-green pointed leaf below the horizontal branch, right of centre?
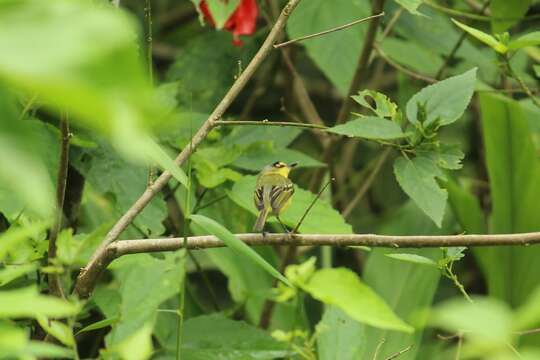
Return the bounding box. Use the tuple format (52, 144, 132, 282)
(303, 268, 413, 332)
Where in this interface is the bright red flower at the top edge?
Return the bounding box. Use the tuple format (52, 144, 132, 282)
(199, 0, 259, 46)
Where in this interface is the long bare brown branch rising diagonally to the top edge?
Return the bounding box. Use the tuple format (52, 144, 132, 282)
(74, 0, 300, 298)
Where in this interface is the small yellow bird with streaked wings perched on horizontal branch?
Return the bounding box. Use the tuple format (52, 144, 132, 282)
(253, 161, 298, 232)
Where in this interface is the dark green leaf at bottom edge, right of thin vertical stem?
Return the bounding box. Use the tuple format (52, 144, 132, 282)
(182, 314, 287, 360)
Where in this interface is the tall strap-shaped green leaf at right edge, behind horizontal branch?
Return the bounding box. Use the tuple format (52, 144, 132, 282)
(475, 94, 540, 306)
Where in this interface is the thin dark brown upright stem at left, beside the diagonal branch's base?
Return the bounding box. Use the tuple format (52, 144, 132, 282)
(47, 114, 70, 298)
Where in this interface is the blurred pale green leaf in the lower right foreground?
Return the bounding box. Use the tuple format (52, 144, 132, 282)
(429, 298, 512, 345)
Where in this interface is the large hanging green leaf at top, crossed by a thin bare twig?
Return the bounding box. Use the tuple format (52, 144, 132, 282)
(287, 0, 370, 95)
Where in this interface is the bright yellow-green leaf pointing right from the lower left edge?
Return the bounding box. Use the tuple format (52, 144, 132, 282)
(0, 286, 80, 318)
